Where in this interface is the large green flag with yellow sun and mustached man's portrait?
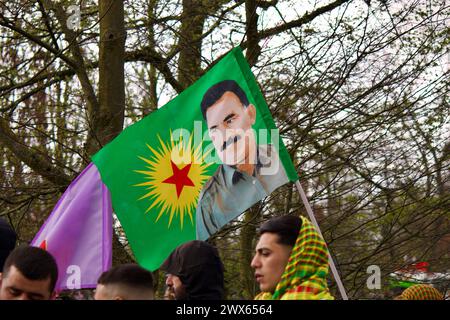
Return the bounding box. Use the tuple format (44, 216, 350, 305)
(93, 47, 297, 270)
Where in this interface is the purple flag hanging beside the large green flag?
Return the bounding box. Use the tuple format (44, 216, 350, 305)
(31, 163, 112, 292)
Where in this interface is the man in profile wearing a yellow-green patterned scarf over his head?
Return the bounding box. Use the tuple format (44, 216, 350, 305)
(251, 215, 334, 300)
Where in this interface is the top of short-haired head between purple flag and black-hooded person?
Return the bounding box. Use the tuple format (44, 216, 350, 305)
(94, 263, 155, 300)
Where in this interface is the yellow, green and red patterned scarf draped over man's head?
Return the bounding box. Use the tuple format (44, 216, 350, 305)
(255, 217, 334, 300)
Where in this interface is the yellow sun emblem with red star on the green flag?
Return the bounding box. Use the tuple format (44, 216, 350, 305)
(134, 132, 211, 228)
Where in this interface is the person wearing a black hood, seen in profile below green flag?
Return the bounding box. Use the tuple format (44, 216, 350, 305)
(161, 240, 224, 300)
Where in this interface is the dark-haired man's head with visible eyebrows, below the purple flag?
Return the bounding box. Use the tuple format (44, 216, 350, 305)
(0, 246, 58, 300)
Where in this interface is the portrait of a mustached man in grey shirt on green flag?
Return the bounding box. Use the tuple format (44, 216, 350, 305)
(196, 80, 288, 240)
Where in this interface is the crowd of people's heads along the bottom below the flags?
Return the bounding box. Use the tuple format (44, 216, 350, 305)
(0, 215, 443, 300)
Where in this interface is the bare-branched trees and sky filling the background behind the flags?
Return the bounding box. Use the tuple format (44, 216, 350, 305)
(0, 0, 450, 299)
